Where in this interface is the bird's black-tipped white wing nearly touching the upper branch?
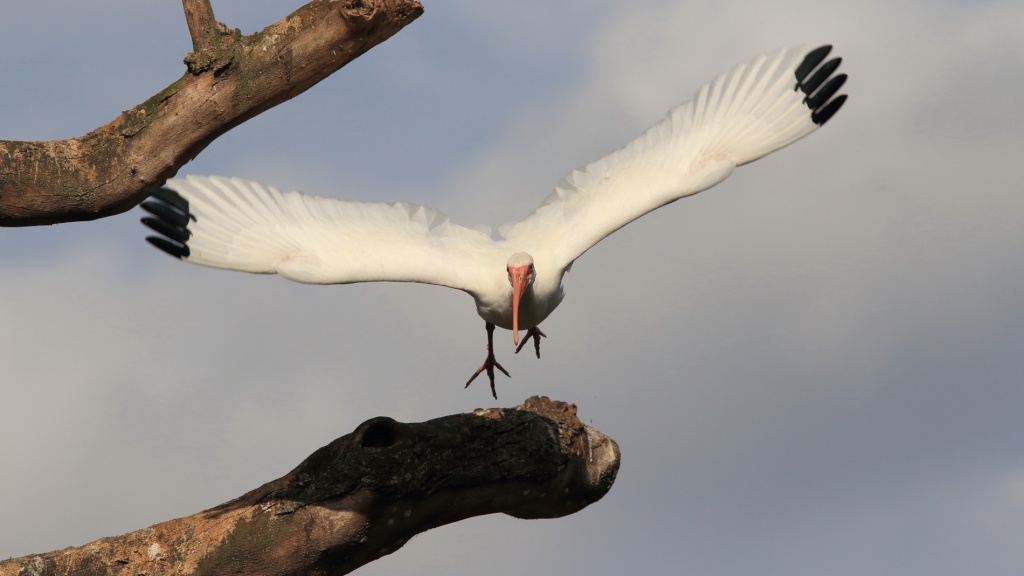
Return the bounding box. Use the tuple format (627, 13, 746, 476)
(142, 176, 504, 293)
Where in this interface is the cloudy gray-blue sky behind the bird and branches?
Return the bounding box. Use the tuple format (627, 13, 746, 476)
(0, 0, 1024, 576)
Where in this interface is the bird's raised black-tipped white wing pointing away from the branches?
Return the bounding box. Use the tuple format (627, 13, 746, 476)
(500, 46, 846, 266)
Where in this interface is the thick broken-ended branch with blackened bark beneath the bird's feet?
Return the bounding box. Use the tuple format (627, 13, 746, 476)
(0, 397, 620, 576)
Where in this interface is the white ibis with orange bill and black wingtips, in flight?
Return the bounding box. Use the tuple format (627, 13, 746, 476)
(142, 46, 846, 399)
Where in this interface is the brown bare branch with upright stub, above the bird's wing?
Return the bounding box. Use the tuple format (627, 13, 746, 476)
(0, 0, 423, 227)
